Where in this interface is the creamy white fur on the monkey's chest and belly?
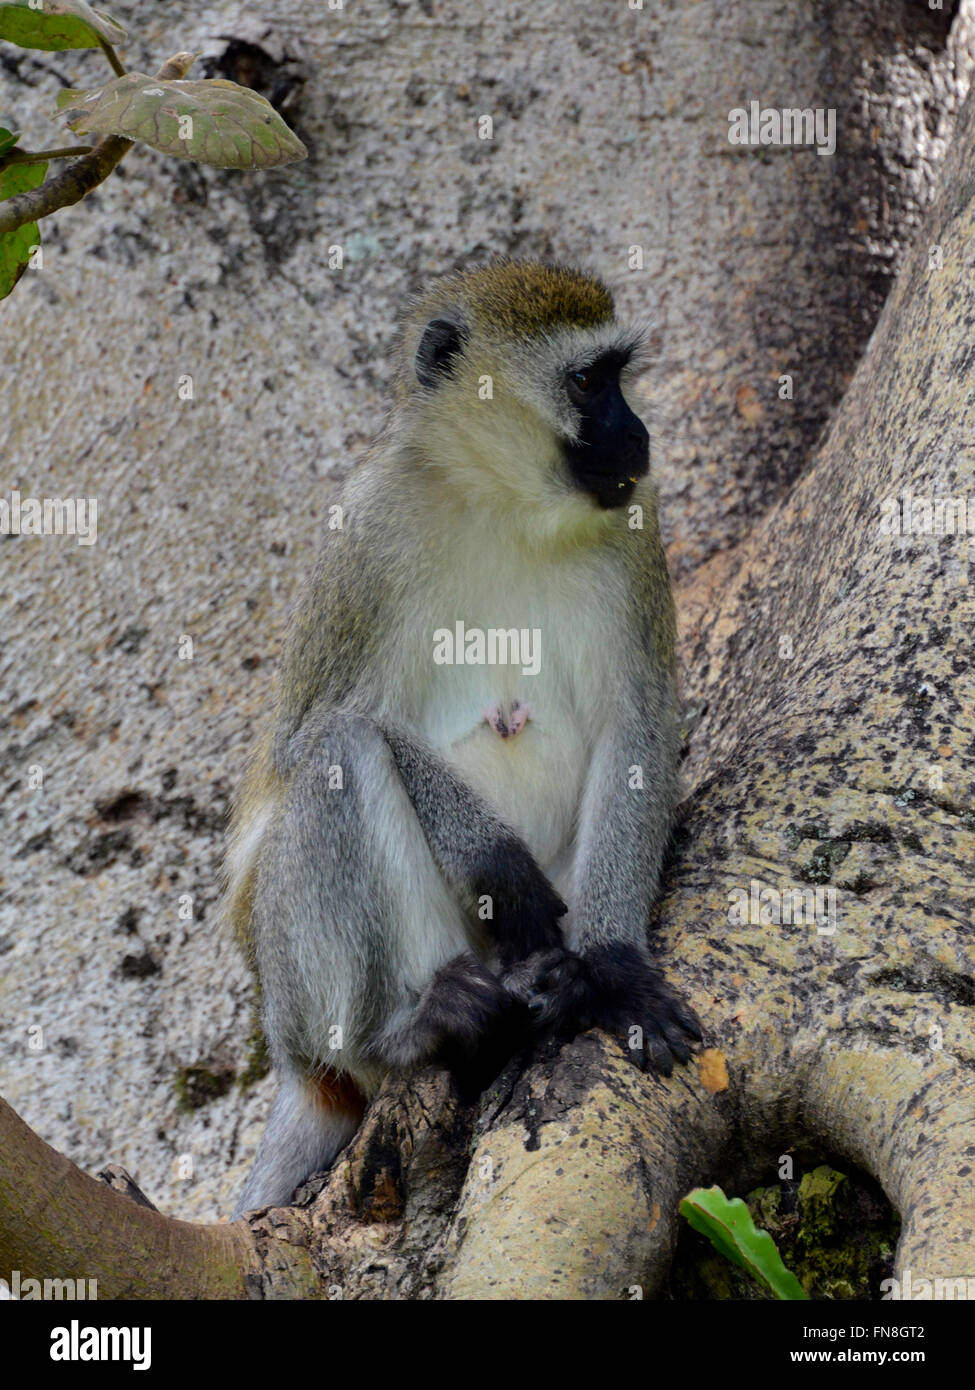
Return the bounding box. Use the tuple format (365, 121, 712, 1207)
(372, 522, 616, 876)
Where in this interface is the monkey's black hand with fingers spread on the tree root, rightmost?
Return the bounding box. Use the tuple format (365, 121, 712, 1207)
(502, 941, 701, 1076)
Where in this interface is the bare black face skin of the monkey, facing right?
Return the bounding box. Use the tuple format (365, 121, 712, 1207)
(565, 353, 650, 509)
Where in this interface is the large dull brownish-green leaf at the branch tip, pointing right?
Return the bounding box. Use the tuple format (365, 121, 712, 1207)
(58, 72, 307, 170)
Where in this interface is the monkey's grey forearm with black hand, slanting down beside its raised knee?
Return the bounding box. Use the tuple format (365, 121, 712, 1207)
(382, 728, 567, 967)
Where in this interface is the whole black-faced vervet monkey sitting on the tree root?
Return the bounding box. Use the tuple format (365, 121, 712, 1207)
(228, 261, 701, 1215)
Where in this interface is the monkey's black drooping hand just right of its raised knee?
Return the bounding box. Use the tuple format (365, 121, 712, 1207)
(474, 835, 569, 970)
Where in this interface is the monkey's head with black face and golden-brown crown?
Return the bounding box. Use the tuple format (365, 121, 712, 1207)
(399, 261, 650, 528)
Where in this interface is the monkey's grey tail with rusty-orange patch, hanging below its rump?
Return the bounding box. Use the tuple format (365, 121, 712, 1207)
(231, 1069, 366, 1220)
